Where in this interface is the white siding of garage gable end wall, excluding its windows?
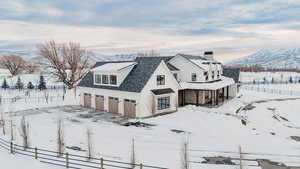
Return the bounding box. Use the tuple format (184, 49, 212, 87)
(137, 61, 179, 117)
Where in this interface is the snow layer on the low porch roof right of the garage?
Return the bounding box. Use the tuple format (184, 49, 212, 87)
(179, 76, 235, 90)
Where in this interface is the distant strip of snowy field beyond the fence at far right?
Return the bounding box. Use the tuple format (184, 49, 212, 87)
(240, 72, 300, 83)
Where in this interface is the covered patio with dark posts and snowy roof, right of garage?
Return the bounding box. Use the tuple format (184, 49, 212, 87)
(178, 77, 237, 107)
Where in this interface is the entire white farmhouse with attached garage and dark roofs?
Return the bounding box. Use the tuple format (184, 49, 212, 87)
(78, 52, 237, 118)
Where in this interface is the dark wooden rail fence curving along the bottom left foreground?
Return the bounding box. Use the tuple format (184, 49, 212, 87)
(0, 138, 168, 169)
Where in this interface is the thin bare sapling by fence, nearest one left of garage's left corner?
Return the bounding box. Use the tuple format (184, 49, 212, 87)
(57, 118, 65, 156)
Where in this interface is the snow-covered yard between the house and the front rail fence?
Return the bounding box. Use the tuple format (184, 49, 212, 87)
(1, 90, 300, 169)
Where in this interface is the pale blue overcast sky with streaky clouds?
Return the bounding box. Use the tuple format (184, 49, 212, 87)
(0, 0, 300, 61)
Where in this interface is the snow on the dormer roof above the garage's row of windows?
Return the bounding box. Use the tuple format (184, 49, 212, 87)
(92, 62, 137, 72)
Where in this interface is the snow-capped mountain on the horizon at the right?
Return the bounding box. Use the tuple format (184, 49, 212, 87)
(226, 48, 300, 69)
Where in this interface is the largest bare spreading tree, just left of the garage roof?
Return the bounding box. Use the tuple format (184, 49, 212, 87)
(38, 41, 92, 88)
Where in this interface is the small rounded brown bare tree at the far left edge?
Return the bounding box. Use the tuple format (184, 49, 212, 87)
(0, 55, 26, 76)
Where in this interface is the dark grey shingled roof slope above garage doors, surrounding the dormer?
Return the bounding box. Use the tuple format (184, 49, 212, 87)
(78, 57, 172, 93)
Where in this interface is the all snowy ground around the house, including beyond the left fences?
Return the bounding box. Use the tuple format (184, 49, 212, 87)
(0, 72, 300, 169)
